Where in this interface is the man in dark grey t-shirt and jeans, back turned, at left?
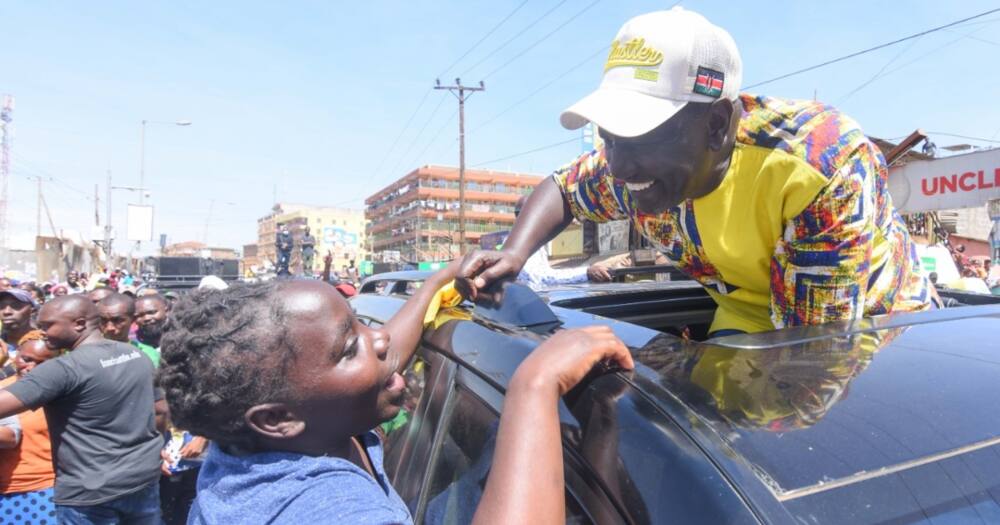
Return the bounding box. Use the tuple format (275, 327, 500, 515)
(0, 295, 162, 523)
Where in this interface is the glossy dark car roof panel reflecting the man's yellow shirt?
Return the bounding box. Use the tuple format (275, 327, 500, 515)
(637, 306, 1000, 501)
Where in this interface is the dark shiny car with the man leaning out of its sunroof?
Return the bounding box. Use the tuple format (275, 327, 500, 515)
(352, 276, 1000, 524)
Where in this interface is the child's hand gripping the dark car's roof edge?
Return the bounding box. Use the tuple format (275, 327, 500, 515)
(511, 326, 635, 396)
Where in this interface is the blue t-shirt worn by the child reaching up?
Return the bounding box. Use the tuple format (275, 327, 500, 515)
(188, 432, 413, 525)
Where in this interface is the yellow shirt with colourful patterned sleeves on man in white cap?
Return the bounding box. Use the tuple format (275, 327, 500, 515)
(553, 95, 930, 332)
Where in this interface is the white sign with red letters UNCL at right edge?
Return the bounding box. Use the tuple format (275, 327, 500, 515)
(889, 149, 1000, 213)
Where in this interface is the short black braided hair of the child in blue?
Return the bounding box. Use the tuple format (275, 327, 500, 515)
(159, 281, 294, 450)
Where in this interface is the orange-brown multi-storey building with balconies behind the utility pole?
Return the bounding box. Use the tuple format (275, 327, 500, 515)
(365, 166, 542, 262)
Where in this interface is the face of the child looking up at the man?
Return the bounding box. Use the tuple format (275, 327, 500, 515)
(283, 281, 405, 443)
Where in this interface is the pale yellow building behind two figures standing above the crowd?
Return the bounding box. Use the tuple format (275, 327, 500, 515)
(256, 203, 368, 273)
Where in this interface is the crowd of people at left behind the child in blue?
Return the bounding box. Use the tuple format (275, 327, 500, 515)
(0, 271, 198, 524)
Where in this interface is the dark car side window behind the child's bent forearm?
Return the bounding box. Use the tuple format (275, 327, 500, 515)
(423, 388, 590, 525)
